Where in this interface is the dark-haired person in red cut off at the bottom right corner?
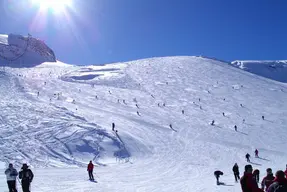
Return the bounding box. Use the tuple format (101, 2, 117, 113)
(267, 170, 287, 192)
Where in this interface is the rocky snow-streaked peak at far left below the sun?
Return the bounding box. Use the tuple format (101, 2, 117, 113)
(0, 34, 56, 67)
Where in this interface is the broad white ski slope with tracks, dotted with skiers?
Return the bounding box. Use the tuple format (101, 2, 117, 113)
(0, 56, 287, 192)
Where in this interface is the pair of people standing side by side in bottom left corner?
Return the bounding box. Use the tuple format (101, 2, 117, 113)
(4, 163, 34, 192)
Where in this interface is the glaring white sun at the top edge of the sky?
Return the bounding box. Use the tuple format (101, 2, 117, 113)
(31, 0, 72, 12)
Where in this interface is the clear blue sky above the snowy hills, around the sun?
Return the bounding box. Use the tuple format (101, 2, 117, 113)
(0, 0, 287, 65)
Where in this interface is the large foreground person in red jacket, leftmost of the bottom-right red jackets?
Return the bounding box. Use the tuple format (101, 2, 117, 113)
(240, 165, 263, 192)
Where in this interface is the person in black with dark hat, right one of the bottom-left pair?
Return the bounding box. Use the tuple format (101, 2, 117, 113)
(19, 163, 34, 192)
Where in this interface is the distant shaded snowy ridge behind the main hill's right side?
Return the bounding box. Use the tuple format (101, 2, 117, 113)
(231, 60, 287, 83)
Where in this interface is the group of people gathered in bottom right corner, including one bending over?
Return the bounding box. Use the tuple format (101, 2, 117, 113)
(214, 163, 287, 192)
